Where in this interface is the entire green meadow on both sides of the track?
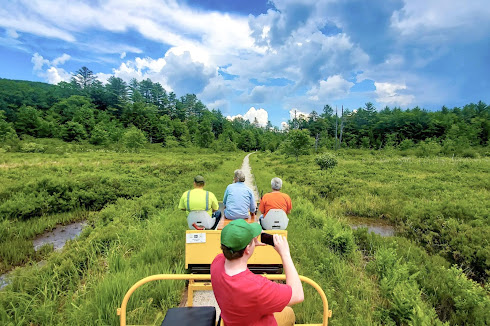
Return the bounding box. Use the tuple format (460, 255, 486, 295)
(0, 145, 490, 325)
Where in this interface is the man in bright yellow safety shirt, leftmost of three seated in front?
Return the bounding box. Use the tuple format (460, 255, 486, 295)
(179, 175, 221, 229)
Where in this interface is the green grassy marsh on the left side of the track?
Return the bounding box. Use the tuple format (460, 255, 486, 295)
(0, 149, 244, 325)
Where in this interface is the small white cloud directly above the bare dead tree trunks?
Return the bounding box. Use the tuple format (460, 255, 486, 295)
(307, 75, 354, 102)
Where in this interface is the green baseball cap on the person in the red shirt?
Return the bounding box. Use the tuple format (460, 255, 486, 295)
(221, 219, 262, 252)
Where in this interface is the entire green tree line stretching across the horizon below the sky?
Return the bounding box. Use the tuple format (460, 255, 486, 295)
(0, 67, 490, 156)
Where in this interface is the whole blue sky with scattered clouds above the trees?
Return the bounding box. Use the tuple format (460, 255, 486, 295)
(0, 0, 490, 126)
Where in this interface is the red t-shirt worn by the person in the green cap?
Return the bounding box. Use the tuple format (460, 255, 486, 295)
(211, 254, 293, 326)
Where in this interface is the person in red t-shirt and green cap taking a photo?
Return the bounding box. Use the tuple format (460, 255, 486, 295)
(211, 219, 304, 326)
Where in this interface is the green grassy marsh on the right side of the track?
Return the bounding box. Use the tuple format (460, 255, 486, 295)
(251, 151, 490, 325)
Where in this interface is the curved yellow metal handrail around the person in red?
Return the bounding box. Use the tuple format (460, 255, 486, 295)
(117, 274, 332, 326)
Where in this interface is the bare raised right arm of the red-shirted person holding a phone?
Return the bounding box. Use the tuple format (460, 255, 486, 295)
(274, 234, 304, 306)
